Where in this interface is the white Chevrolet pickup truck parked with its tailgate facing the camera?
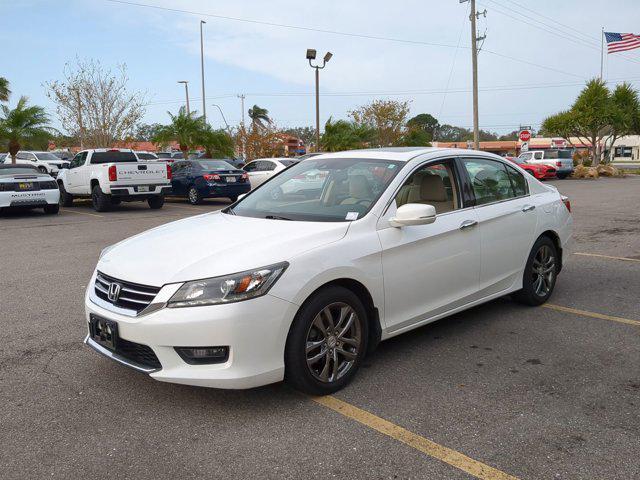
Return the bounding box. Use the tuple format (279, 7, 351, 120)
(57, 148, 171, 212)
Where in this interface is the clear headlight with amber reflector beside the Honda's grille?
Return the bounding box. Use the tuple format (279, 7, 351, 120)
(167, 262, 289, 308)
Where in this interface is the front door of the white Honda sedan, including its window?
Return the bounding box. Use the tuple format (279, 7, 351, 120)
(378, 159, 480, 333)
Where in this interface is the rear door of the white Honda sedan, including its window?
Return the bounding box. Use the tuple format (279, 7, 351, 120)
(459, 157, 537, 297)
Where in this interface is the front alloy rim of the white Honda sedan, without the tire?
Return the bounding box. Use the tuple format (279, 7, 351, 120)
(306, 302, 362, 383)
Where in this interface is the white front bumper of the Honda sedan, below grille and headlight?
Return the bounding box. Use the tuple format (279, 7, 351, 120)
(85, 280, 298, 389)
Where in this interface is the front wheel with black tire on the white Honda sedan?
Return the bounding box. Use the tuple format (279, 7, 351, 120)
(284, 286, 369, 395)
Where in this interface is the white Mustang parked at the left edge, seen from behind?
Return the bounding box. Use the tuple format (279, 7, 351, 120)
(0, 164, 60, 214)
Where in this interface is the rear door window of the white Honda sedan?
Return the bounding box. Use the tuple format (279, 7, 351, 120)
(462, 158, 515, 205)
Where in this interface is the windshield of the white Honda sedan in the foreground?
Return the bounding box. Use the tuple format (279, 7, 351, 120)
(224, 158, 403, 222)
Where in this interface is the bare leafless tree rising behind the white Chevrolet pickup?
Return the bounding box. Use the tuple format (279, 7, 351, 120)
(45, 59, 146, 148)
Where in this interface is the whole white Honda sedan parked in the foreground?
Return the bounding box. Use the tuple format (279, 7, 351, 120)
(86, 148, 572, 394)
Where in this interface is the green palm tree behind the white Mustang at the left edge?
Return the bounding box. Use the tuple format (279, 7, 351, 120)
(0, 97, 53, 163)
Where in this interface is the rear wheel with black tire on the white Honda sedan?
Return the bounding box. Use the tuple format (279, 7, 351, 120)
(513, 236, 560, 306)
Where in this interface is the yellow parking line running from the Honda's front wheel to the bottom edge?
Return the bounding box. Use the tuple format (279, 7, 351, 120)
(312, 396, 518, 480)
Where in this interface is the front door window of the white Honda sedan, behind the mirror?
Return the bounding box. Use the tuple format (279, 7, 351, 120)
(396, 161, 460, 214)
